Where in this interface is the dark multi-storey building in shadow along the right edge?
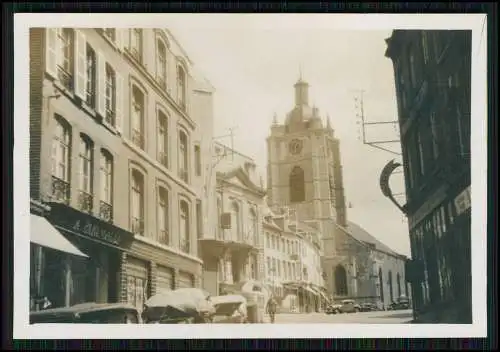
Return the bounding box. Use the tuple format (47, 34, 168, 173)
(386, 30, 472, 323)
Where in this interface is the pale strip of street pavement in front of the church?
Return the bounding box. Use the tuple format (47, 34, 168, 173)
(266, 310, 413, 324)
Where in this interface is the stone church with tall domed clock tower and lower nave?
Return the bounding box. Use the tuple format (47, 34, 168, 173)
(267, 77, 409, 307)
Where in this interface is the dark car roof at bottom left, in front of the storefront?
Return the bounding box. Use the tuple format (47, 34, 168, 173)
(30, 302, 142, 324)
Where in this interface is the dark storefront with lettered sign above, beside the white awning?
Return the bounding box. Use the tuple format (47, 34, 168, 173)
(45, 203, 133, 306)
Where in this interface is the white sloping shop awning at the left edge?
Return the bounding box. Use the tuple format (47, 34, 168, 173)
(30, 214, 88, 257)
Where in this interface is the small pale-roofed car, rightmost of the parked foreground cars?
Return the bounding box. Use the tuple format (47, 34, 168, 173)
(212, 295, 248, 324)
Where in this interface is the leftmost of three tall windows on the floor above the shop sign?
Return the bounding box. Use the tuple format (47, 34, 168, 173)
(52, 115, 71, 203)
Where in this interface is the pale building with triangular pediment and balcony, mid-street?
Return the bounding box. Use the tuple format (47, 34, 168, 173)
(200, 143, 265, 295)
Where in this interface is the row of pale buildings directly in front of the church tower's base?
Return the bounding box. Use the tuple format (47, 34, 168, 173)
(263, 208, 327, 311)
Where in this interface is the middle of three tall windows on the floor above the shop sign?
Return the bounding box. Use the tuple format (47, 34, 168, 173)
(78, 135, 93, 214)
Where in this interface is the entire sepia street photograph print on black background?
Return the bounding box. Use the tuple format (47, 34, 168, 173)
(14, 14, 486, 337)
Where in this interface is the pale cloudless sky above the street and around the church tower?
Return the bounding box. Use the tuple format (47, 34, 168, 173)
(167, 15, 410, 255)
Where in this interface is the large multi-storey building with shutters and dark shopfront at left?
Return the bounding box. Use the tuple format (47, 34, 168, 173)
(30, 28, 212, 308)
